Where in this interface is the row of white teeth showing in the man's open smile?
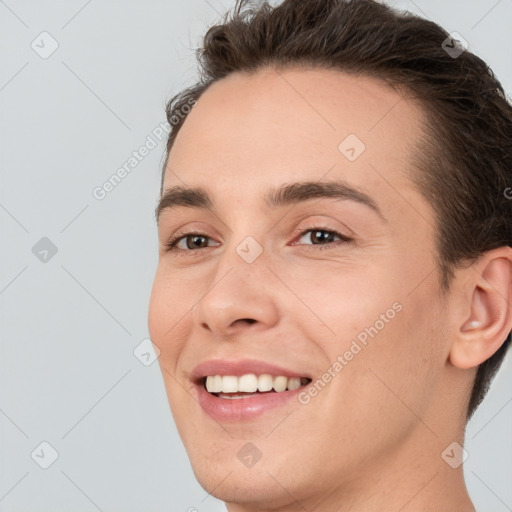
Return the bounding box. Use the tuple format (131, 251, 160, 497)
(206, 373, 304, 398)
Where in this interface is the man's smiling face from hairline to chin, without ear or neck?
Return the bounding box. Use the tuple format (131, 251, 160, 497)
(149, 69, 448, 504)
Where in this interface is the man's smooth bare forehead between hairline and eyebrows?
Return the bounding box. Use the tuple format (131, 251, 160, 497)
(164, 69, 423, 214)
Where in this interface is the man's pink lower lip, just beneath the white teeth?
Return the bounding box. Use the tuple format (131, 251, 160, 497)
(197, 385, 304, 422)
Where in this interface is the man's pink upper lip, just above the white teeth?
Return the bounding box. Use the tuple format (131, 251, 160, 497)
(190, 359, 309, 382)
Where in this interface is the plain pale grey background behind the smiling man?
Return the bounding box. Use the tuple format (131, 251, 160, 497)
(0, 0, 512, 512)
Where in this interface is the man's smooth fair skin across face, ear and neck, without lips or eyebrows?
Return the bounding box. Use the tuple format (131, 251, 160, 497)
(149, 68, 512, 512)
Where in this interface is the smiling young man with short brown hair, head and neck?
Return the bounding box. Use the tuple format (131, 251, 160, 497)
(149, 0, 512, 512)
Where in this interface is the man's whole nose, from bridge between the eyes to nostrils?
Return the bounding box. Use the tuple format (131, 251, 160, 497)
(194, 236, 277, 334)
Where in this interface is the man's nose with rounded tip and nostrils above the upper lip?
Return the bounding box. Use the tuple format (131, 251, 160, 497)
(192, 254, 279, 336)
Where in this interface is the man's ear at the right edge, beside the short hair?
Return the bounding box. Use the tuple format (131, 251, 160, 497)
(449, 247, 512, 369)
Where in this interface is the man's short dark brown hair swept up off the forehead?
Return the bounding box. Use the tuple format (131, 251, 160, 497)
(162, 0, 512, 418)
